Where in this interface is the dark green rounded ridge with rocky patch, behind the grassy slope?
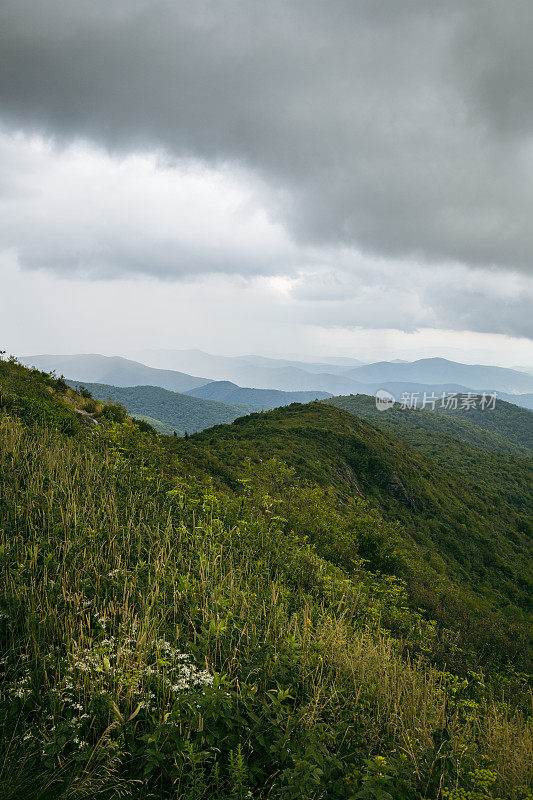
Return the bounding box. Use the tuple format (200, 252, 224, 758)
(180, 403, 533, 664)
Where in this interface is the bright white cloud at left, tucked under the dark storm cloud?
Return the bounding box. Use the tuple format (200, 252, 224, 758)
(0, 132, 302, 280)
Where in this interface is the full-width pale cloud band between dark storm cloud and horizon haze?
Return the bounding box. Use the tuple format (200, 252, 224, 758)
(0, 127, 533, 337)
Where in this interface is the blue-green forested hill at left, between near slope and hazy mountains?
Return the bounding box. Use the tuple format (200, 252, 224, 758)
(67, 381, 257, 436)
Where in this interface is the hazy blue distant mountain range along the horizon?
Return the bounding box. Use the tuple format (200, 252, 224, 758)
(20, 354, 533, 409)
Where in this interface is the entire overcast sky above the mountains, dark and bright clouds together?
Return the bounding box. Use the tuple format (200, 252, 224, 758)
(0, 0, 533, 365)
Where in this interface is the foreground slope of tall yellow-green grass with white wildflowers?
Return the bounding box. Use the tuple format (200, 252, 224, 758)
(0, 417, 533, 800)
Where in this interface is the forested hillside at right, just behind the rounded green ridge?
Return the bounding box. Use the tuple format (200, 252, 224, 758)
(324, 394, 533, 456)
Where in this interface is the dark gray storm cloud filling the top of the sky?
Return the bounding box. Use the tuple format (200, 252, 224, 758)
(0, 0, 533, 273)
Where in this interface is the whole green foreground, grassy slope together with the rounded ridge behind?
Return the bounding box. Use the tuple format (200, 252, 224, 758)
(0, 359, 533, 800)
